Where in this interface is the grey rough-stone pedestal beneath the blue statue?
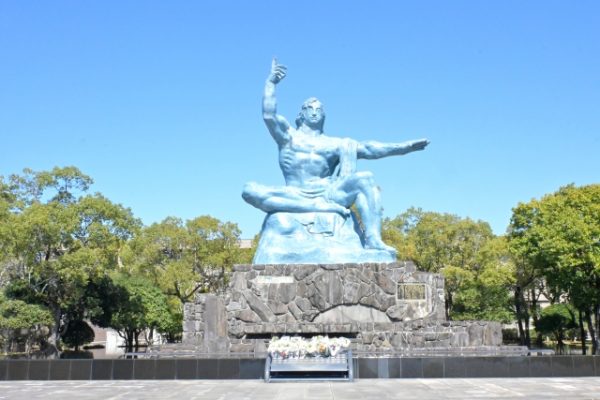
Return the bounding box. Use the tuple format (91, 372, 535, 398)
(183, 262, 502, 352)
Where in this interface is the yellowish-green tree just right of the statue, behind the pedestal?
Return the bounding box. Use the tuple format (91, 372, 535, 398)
(382, 208, 514, 321)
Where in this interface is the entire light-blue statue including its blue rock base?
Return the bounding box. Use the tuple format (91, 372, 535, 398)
(242, 59, 429, 264)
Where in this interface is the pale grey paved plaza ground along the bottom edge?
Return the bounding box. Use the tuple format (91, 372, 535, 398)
(0, 378, 600, 400)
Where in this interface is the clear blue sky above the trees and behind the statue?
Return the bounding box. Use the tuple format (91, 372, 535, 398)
(0, 0, 600, 238)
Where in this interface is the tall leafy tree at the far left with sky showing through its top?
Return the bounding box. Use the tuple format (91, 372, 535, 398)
(3, 167, 140, 354)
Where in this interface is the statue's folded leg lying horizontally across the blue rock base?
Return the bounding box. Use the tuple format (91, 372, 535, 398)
(242, 182, 350, 216)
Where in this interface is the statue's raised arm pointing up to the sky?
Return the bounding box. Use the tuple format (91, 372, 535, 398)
(263, 58, 290, 146)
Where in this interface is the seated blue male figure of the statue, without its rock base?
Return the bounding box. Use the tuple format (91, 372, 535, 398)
(242, 60, 429, 253)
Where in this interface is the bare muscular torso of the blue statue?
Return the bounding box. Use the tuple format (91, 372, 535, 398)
(279, 129, 340, 187)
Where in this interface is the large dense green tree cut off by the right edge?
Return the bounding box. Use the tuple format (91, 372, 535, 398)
(509, 185, 600, 353)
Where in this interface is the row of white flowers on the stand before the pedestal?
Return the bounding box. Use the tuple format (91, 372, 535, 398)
(268, 336, 350, 359)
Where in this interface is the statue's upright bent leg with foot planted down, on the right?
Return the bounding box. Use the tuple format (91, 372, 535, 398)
(332, 171, 396, 254)
